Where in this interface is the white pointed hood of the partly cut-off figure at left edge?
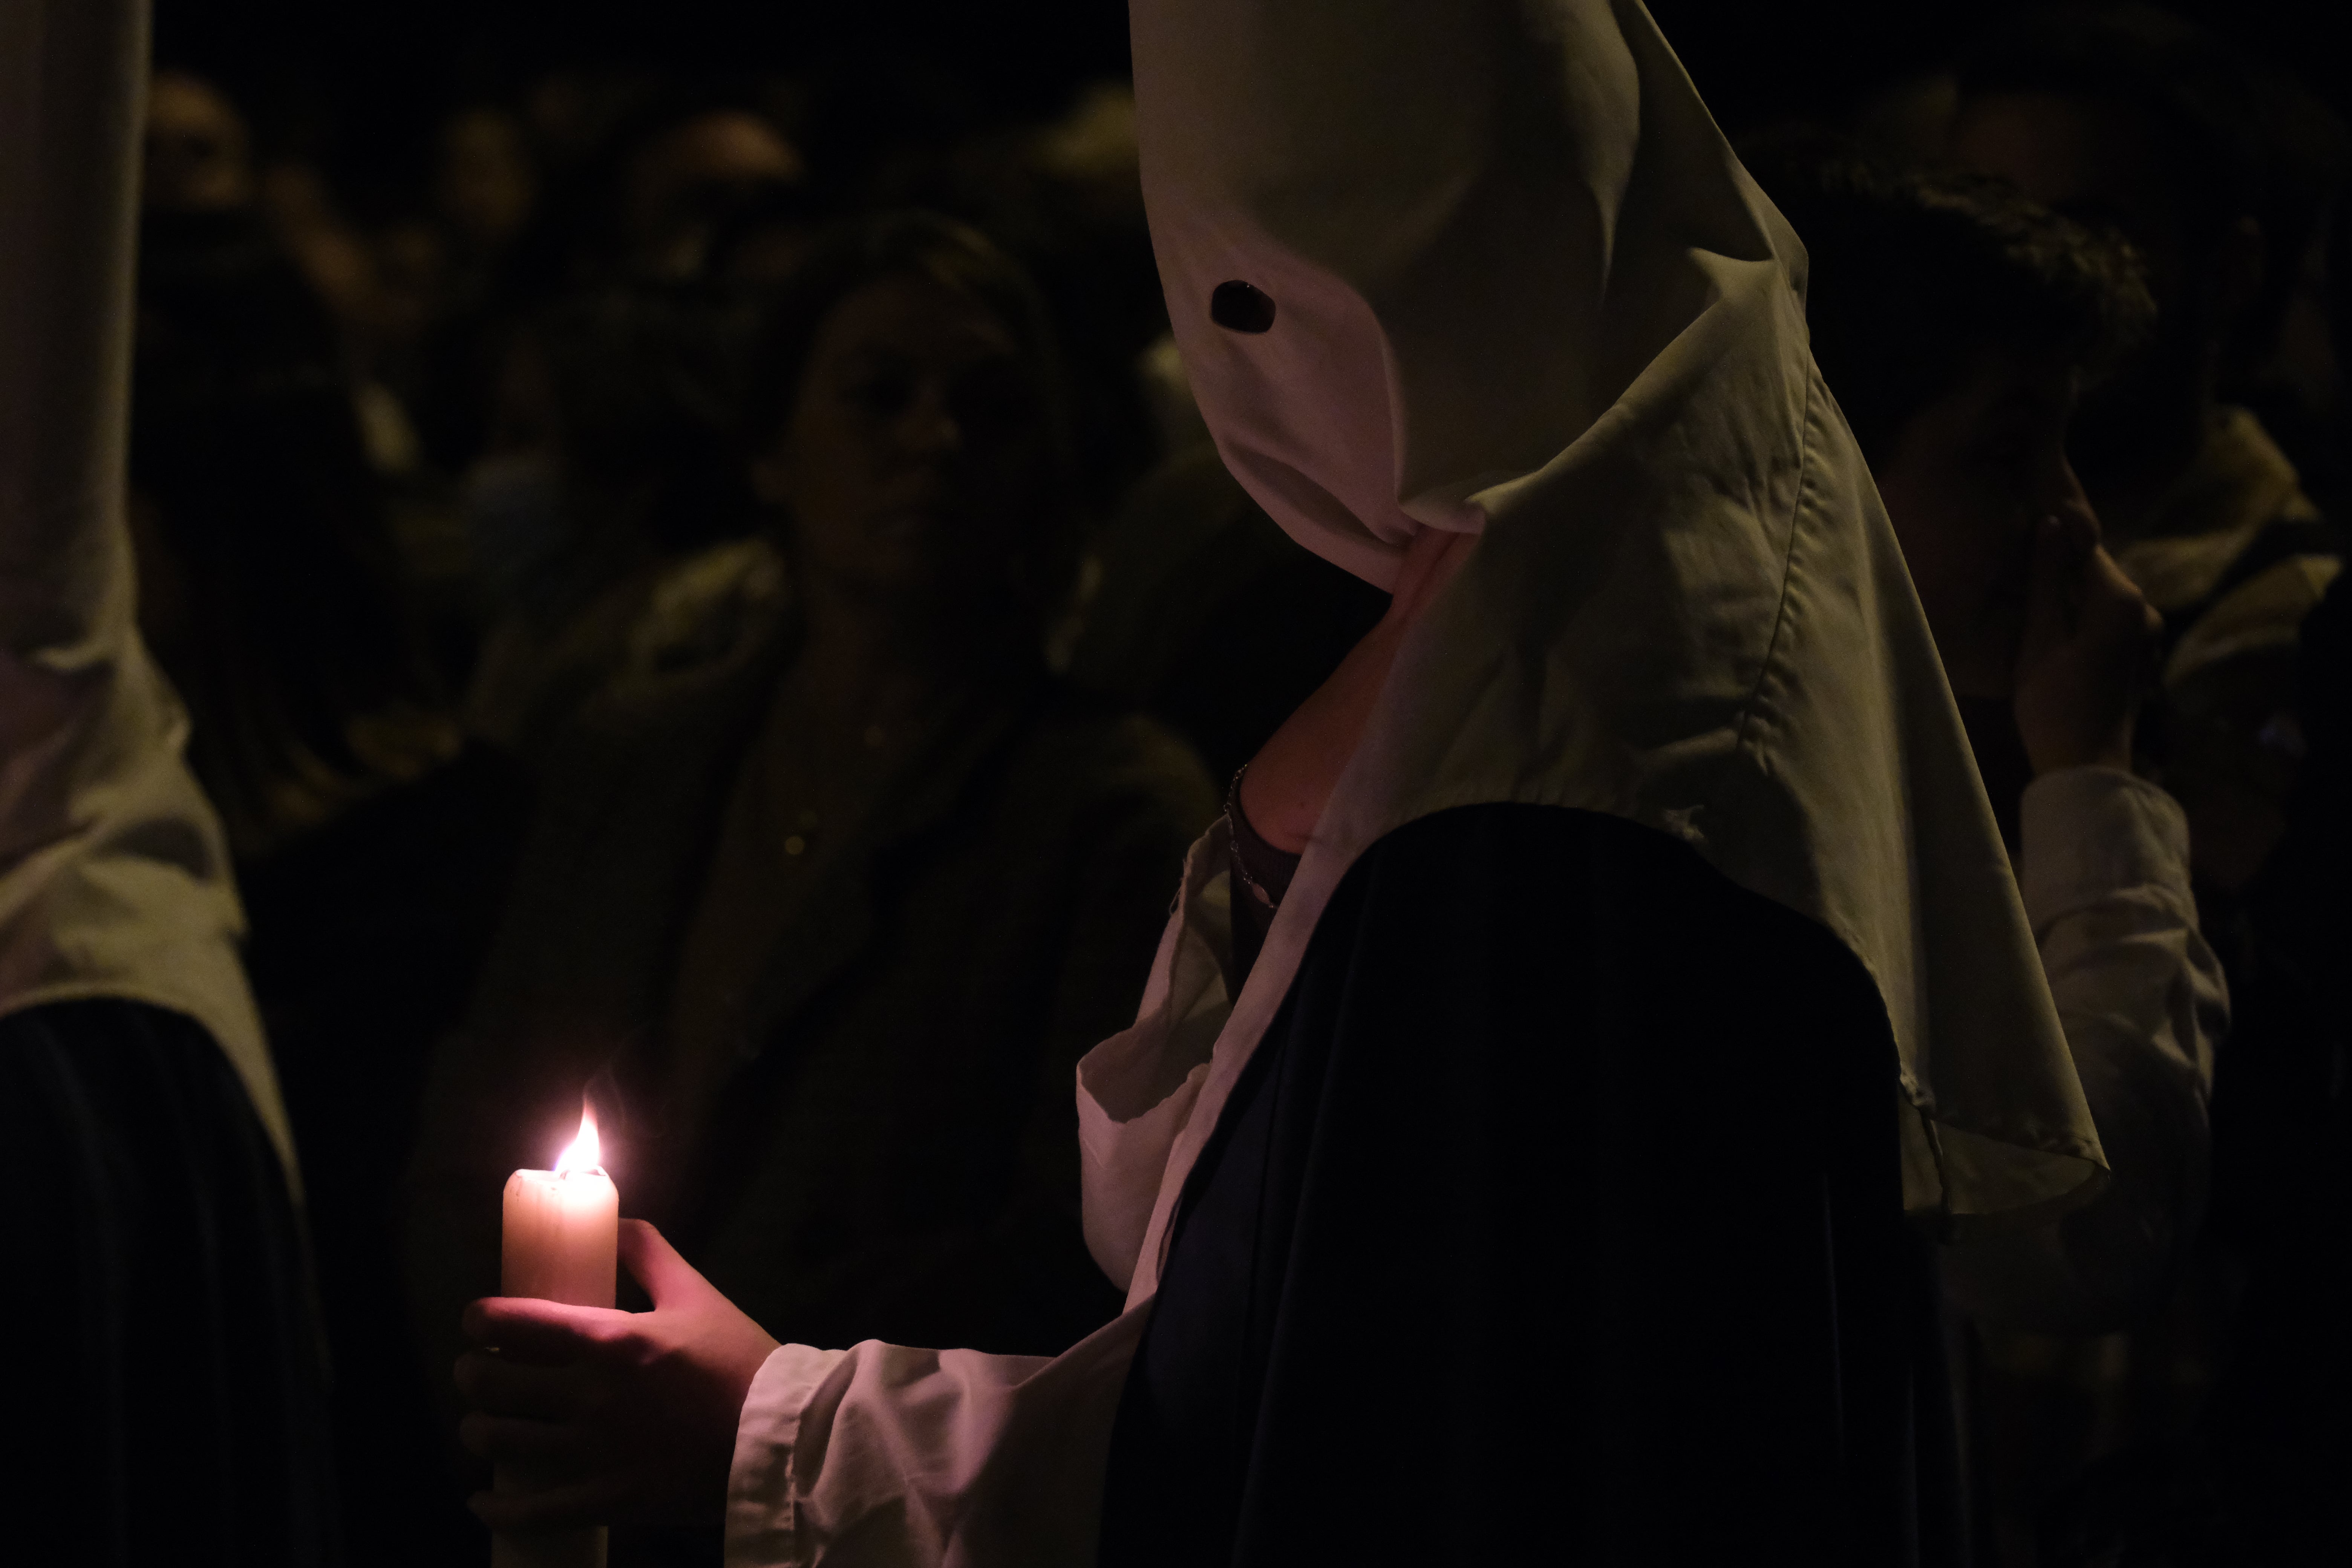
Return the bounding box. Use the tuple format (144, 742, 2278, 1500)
(0, 0, 294, 1182)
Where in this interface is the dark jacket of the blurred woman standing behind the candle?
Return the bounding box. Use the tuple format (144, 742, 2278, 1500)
(409, 550, 1216, 1401)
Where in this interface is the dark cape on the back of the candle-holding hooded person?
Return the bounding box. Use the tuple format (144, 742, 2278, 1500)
(1101, 804, 1966, 1568)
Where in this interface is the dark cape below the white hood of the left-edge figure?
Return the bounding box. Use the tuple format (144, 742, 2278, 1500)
(0, 999, 341, 1568)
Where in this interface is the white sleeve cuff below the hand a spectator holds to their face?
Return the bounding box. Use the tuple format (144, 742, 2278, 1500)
(2018, 766, 2197, 933)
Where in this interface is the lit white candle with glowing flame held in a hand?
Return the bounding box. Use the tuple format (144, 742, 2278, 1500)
(489, 1102, 621, 1568)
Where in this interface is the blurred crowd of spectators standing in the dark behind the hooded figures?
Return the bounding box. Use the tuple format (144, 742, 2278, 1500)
(106, 9, 2352, 1566)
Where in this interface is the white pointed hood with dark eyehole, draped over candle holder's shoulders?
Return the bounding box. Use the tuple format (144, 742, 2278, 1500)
(1131, 0, 2103, 1269)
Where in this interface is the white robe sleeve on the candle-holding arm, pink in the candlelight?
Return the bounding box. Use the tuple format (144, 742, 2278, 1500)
(727, 823, 1233, 1568)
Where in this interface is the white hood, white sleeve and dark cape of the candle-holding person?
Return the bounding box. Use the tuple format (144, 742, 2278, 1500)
(729, 0, 2103, 1563)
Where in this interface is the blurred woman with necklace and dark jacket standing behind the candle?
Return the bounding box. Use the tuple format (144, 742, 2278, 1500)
(409, 216, 1216, 1561)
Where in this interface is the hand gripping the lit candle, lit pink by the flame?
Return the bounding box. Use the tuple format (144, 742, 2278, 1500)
(456, 1220, 776, 1530)
